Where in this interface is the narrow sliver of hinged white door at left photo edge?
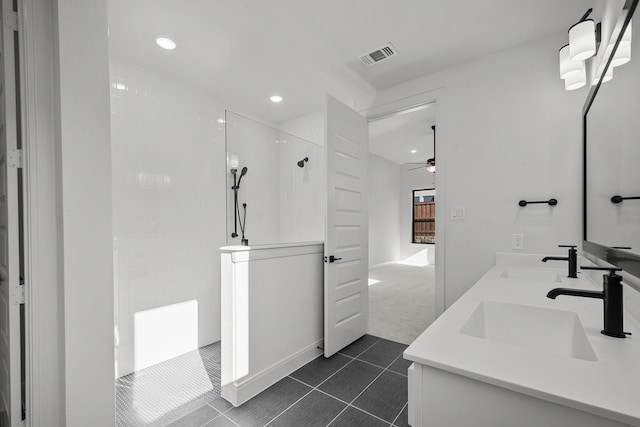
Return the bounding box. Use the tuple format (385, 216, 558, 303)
(0, 0, 22, 426)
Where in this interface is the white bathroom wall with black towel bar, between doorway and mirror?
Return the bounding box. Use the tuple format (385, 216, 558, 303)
(358, 32, 586, 306)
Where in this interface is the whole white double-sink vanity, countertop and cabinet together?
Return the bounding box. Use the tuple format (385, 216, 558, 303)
(404, 254, 640, 427)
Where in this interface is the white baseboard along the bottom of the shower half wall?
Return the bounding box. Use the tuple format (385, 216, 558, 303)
(222, 340, 323, 406)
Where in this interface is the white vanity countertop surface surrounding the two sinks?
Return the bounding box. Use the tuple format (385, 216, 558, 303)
(404, 255, 640, 425)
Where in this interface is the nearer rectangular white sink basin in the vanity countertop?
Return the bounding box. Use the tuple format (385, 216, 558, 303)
(460, 301, 598, 361)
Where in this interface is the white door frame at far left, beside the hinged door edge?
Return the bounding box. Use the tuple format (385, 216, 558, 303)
(18, 0, 65, 426)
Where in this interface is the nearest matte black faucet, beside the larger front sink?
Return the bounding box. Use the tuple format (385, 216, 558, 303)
(547, 266, 628, 338)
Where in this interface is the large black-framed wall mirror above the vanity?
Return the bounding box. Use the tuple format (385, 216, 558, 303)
(583, 0, 640, 277)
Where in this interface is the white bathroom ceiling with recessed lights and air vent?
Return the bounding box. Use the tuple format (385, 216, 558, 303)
(108, 0, 593, 124)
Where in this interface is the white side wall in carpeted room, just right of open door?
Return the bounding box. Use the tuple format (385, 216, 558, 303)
(368, 154, 400, 266)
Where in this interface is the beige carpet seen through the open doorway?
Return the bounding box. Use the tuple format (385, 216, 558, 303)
(369, 263, 435, 344)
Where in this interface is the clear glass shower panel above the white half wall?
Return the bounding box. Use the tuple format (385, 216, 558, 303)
(225, 111, 325, 246)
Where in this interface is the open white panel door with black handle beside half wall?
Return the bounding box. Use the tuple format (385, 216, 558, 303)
(324, 95, 369, 357)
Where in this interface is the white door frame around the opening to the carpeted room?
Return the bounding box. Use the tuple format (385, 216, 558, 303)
(358, 88, 447, 318)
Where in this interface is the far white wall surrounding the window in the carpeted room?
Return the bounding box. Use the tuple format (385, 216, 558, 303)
(400, 166, 439, 264)
